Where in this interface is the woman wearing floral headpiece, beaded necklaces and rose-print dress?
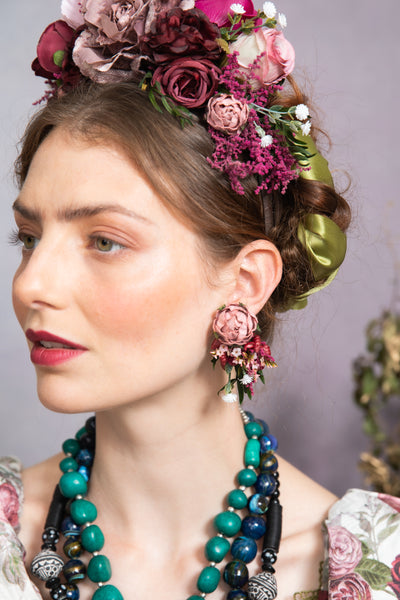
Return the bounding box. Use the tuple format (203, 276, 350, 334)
(0, 0, 400, 600)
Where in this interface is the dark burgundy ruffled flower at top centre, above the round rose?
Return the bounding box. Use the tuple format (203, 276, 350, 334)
(140, 8, 221, 64)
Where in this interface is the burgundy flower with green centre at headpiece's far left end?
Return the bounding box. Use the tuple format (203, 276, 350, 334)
(32, 20, 80, 85)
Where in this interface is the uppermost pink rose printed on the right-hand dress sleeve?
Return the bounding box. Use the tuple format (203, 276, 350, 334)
(328, 527, 362, 578)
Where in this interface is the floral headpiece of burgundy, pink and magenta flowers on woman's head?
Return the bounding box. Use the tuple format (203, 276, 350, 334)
(32, 0, 322, 194)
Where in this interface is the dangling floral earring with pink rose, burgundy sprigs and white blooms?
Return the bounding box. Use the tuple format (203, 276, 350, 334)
(211, 303, 277, 403)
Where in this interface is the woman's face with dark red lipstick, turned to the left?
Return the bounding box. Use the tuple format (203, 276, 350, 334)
(13, 129, 228, 412)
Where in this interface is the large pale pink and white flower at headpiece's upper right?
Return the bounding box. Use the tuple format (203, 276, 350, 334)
(229, 27, 295, 85)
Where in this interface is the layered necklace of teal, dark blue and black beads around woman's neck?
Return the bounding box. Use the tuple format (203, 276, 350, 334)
(31, 409, 282, 600)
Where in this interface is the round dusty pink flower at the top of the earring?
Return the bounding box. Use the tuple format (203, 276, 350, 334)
(213, 304, 258, 346)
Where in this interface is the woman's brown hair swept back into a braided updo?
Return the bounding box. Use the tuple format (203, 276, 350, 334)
(16, 83, 350, 337)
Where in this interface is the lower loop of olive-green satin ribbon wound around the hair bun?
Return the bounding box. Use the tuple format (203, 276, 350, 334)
(290, 214, 347, 309)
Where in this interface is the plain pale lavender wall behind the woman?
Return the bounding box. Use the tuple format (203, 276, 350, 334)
(0, 0, 400, 494)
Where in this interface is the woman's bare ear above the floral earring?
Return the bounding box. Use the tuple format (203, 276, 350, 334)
(229, 240, 282, 314)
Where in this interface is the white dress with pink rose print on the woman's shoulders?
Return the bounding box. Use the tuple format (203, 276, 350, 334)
(0, 457, 400, 600)
